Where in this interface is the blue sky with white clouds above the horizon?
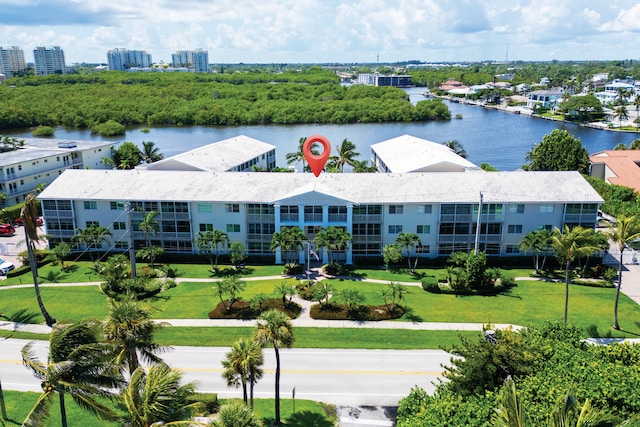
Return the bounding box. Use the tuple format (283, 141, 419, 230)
(0, 0, 640, 64)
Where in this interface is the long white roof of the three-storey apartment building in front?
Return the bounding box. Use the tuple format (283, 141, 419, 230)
(38, 169, 603, 204)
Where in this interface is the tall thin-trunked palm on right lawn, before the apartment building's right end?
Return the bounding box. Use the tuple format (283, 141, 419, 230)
(551, 225, 600, 325)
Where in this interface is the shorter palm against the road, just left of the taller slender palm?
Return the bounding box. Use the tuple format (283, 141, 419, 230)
(222, 338, 264, 410)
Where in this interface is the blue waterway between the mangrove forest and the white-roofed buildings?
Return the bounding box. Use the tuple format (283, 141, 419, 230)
(4, 88, 640, 170)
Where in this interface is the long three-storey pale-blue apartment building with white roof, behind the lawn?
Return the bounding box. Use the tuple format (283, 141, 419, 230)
(38, 166, 603, 263)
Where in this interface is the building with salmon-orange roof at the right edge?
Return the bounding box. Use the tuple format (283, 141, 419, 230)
(589, 150, 640, 191)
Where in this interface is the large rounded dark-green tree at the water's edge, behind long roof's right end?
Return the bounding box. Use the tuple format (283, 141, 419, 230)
(526, 129, 590, 175)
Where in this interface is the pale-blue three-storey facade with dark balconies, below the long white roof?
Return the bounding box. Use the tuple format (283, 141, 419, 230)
(42, 193, 598, 263)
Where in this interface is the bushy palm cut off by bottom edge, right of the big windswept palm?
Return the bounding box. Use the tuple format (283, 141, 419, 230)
(122, 363, 206, 427)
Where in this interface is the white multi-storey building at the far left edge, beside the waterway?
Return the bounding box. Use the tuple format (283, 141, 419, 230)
(0, 138, 116, 206)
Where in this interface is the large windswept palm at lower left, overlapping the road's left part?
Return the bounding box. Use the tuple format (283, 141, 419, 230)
(22, 322, 122, 427)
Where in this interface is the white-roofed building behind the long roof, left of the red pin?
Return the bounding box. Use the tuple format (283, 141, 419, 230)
(138, 135, 276, 172)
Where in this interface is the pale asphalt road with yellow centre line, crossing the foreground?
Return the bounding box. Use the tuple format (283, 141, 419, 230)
(0, 338, 450, 406)
